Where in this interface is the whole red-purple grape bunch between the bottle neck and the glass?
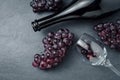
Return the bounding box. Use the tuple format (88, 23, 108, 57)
(32, 29, 74, 70)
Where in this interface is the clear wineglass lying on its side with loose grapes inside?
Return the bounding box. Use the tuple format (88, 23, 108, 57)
(77, 33, 120, 76)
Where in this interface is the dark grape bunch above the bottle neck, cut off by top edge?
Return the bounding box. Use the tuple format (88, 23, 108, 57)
(30, 0, 62, 13)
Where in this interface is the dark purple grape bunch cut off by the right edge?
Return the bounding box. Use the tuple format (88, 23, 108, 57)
(94, 20, 120, 50)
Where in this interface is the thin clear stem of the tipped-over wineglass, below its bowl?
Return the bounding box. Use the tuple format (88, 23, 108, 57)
(103, 59, 120, 76)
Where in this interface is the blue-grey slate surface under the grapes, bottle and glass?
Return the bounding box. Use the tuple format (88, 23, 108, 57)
(0, 0, 120, 80)
